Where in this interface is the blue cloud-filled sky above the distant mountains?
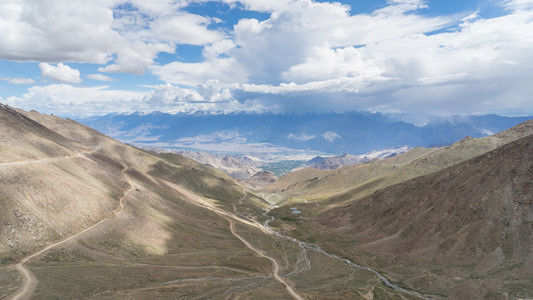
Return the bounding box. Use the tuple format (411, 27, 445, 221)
(0, 0, 533, 116)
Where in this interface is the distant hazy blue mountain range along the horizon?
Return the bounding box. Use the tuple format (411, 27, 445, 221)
(79, 112, 530, 158)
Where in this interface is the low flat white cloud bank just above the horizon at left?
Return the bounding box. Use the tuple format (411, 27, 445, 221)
(4, 84, 267, 115)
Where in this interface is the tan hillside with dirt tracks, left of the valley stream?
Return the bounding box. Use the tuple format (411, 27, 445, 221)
(0, 106, 424, 299)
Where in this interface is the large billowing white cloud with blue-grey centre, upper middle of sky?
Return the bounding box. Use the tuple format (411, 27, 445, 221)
(152, 0, 454, 90)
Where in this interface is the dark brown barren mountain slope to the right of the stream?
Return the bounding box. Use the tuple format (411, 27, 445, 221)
(270, 135, 533, 299)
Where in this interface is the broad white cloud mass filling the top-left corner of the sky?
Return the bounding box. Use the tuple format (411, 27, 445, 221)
(0, 0, 224, 74)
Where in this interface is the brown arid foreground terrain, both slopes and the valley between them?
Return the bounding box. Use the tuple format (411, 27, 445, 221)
(0, 106, 533, 299)
